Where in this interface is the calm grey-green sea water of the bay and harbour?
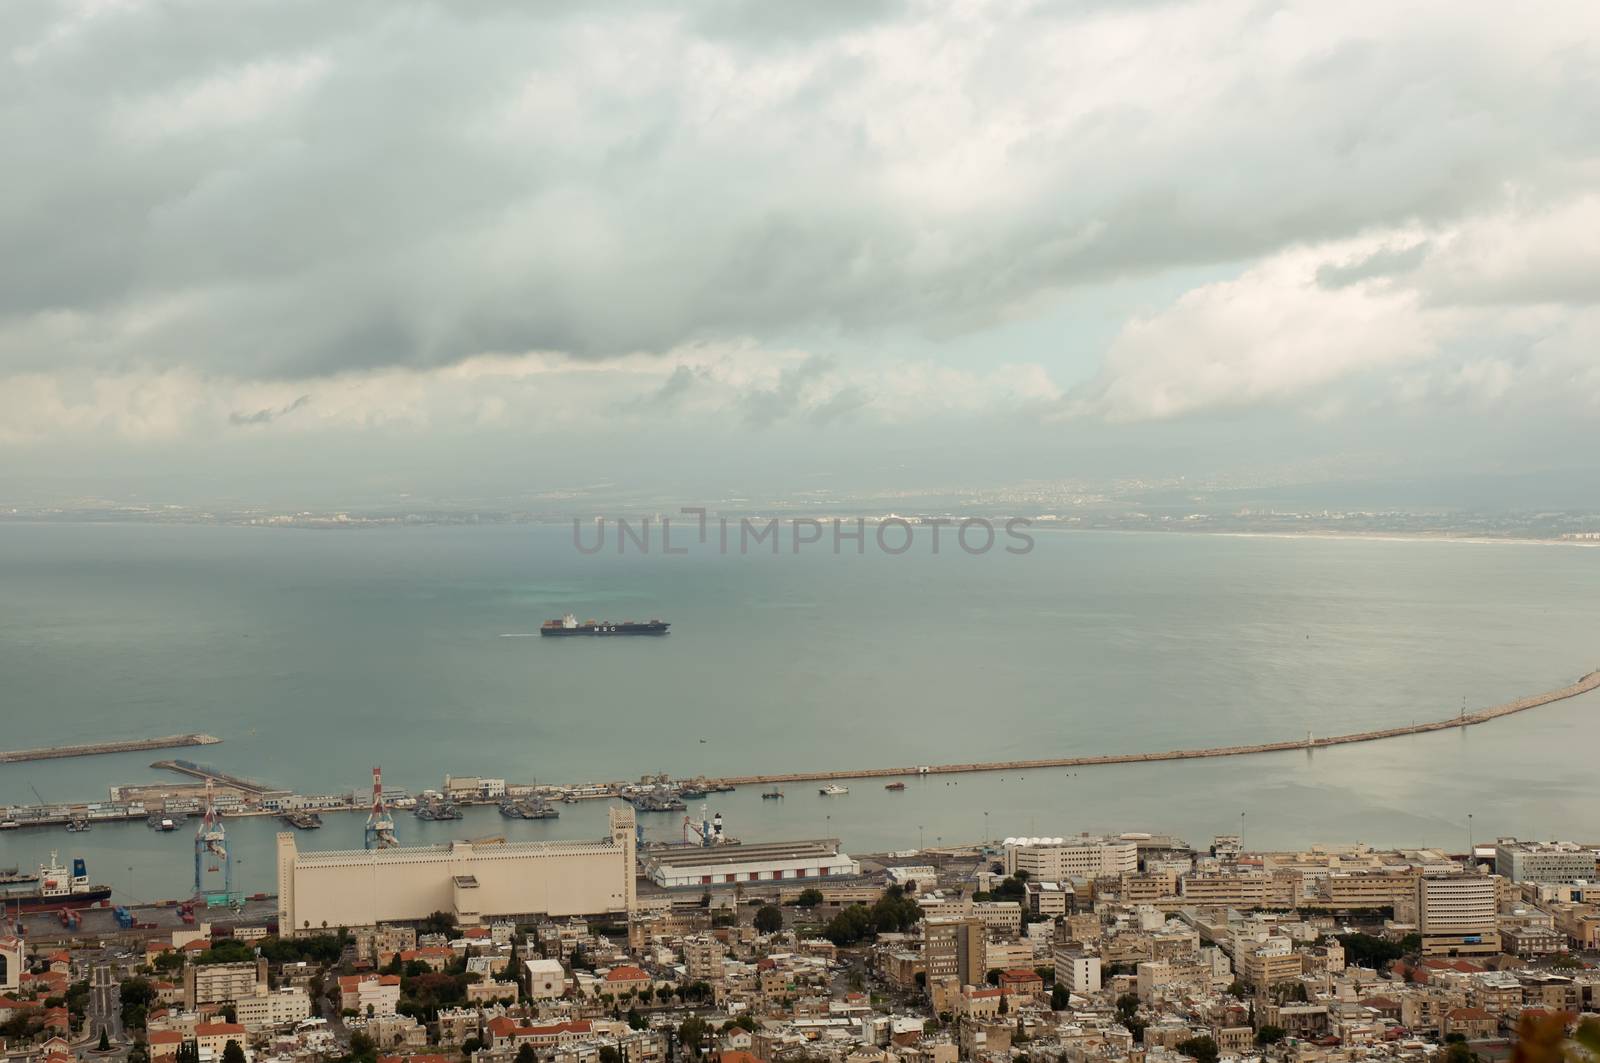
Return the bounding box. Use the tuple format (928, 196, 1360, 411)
(0, 525, 1600, 898)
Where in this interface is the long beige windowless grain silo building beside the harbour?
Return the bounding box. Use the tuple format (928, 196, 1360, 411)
(278, 807, 635, 933)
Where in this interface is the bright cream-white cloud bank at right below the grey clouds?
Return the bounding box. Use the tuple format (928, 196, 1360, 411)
(1064, 188, 1600, 421)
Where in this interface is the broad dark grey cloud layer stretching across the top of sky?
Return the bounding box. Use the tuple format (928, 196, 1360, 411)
(0, 0, 1600, 382)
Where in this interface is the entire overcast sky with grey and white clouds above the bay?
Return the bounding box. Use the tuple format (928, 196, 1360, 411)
(0, 0, 1600, 504)
